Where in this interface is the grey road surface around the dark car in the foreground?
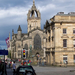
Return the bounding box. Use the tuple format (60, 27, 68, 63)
(0, 64, 75, 75)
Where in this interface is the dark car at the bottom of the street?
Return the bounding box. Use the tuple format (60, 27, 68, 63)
(16, 65, 36, 75)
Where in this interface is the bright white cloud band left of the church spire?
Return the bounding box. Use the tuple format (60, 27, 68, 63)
(0, 7, 28, 18)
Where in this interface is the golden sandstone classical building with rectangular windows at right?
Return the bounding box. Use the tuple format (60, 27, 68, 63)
(44, 12, 75, 65)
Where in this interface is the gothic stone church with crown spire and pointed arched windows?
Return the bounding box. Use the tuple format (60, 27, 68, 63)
(11, 0, 46, 59)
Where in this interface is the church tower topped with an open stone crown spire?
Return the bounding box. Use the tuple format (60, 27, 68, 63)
(27, 0, 41, 32)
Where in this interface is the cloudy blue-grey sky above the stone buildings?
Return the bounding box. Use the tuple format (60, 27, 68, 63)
(0, 0, 75, 49)
